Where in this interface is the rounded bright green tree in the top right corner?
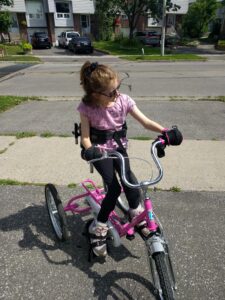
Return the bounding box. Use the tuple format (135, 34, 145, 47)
(183, 0, 218, 38)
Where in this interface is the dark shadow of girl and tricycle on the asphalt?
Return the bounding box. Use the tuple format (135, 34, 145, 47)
(0, 205, 158, 300)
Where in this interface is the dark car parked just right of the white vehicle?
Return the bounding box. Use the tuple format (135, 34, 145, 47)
(68, 36, 94, 53)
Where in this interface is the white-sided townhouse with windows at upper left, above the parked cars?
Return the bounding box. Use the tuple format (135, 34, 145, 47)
(1, 0, 95, 43)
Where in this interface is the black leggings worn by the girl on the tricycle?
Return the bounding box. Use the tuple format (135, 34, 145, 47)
(93, 151, 141, 223)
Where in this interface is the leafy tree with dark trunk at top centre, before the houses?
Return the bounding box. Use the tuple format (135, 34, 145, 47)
(96, 0, 179, 39)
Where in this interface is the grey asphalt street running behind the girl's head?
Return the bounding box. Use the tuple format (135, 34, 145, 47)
(0, 57, 225, 100)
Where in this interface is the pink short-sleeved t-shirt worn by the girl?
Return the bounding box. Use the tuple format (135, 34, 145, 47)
(77, 94, 136, 149)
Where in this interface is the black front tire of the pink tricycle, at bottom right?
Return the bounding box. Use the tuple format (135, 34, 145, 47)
(153, 252, 175, 300)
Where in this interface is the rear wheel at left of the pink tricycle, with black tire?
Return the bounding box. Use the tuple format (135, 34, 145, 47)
(45, 184, 69, 241)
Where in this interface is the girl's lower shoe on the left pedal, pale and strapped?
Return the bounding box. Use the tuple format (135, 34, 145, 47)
(88, 220, 109, 257)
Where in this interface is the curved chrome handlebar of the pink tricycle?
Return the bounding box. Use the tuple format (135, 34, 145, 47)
(89, 139, 164, 188)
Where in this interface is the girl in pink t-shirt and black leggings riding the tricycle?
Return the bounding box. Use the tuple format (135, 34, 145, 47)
(78, 61, 182, 256)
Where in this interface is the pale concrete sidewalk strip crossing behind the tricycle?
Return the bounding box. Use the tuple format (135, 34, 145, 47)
(0, 136, 225, 191)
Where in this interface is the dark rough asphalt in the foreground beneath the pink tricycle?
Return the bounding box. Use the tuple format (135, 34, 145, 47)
(0, 186, 225, 300)
